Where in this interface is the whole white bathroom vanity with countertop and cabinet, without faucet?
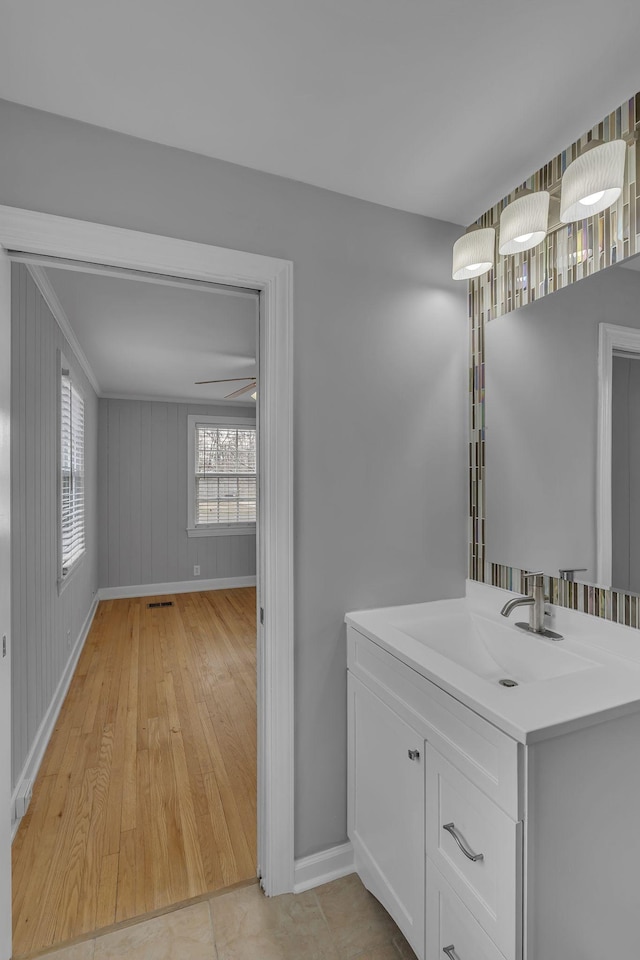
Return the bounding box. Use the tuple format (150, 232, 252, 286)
(346, 582, 640, 960)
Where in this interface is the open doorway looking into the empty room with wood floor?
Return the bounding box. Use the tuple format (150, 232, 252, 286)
(12, 255, 258, 956)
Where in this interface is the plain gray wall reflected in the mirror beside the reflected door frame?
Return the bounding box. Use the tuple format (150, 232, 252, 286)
(485, 267, 640, 587)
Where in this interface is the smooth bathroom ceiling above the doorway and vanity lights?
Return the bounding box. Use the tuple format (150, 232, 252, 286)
(0, 0, 640, 224)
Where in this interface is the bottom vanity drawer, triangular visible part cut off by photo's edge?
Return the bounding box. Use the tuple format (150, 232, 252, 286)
(426, 860, 505, 960)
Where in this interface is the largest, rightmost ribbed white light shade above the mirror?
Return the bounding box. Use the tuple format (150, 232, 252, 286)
(560, 140, 627, 223)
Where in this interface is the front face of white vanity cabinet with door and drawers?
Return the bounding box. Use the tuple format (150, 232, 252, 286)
(348, 627, 522, 960)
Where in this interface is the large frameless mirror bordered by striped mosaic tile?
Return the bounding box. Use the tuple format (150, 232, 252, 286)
(485, 258, 640, 593)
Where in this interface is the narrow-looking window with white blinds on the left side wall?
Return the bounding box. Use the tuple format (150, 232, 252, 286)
(60, 357, 85, 581)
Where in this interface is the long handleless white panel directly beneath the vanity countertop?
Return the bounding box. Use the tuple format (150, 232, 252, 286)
(347, 626, 522, 820)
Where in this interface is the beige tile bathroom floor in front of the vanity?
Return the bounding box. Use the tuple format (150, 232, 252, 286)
(37, 874, 415, 960)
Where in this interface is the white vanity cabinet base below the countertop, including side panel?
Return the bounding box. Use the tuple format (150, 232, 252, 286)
(347, 624, 640, 960)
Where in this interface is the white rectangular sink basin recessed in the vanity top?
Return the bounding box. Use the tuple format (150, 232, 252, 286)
(388, 608, 596, 686)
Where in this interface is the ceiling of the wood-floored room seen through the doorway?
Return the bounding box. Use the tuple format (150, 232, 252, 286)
(44, 268, 258, 404)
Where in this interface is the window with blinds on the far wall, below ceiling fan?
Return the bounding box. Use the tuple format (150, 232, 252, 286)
(188, 417, 257, 536)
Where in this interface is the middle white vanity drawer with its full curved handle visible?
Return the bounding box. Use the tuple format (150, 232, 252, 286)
(426, 745, 522, 960)
